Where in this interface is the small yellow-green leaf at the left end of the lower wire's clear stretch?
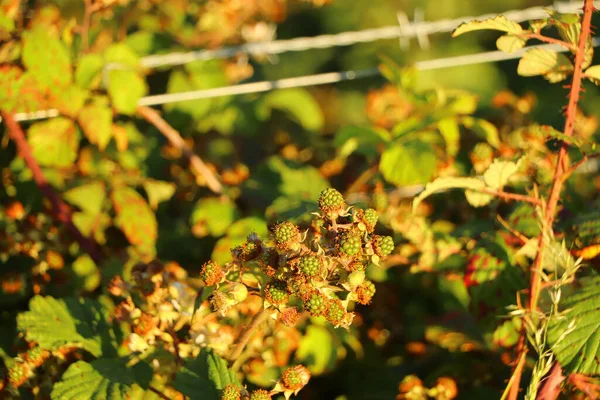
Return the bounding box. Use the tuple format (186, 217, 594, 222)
(108, 70, 148, 115)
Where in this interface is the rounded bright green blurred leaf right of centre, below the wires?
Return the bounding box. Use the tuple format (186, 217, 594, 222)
(379, 140, 437, 186)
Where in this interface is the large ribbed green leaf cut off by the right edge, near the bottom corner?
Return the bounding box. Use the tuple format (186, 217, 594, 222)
(548, 276, 600, 375)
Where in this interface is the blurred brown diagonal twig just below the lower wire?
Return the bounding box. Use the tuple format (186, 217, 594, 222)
(137, 106, 223, 193)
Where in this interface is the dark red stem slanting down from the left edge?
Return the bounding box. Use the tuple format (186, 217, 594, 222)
(2, 112, 103, 265)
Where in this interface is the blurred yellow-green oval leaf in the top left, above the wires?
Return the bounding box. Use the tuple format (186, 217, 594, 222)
(23, 27, 72, 88)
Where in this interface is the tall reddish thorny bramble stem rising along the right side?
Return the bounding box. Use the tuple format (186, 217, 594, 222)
(508, 0, 594, 400)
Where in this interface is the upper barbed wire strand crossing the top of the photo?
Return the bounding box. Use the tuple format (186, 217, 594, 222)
(138, 1, 600, 68)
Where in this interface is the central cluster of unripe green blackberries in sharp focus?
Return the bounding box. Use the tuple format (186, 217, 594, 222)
(200, 188, 394, 327)
